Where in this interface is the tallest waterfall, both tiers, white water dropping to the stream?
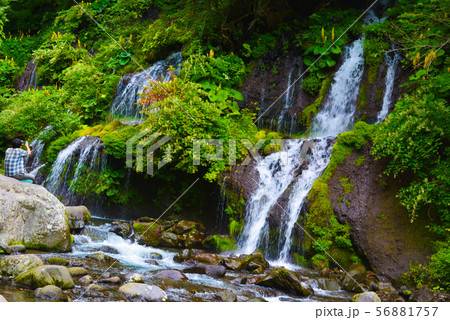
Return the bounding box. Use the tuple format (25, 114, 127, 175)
(239, 37, 364, 263)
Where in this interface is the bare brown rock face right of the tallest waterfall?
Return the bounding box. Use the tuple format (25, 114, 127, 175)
(328, 145, 432, 280)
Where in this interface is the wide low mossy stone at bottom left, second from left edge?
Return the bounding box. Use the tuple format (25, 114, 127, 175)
(14, 265, 74, 289)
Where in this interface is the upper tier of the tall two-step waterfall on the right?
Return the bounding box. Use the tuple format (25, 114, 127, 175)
(311, 37, 364, 137)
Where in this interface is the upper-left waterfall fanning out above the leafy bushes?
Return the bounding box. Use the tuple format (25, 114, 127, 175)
(110, 52, 183, 120)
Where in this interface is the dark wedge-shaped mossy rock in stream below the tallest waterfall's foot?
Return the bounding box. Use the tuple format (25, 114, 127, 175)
(256, 268, 311, 296)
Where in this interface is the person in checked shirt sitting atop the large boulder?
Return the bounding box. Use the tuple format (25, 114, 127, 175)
(5, 138, 36, 183)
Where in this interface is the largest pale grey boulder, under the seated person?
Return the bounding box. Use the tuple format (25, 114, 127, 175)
(0, 175, 72, 252)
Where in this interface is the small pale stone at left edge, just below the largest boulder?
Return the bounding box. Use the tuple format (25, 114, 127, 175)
(0, 254, 44, 278)
